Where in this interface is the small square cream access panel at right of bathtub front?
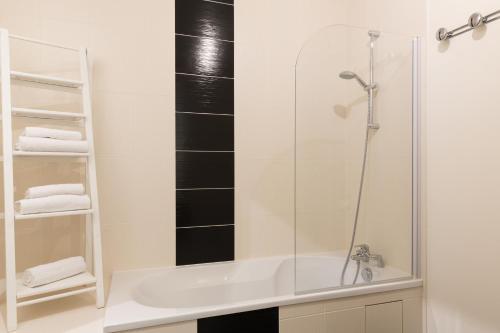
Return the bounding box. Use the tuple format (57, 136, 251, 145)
(366, 301, 403, 333)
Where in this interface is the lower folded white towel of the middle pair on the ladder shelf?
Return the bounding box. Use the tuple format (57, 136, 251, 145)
(16, 194, 90, 214)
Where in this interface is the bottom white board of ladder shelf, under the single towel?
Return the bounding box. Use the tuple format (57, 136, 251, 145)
(17, 272, 96, 299)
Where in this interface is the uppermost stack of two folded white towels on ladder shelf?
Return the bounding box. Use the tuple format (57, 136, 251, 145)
(16, 127, 89, 153)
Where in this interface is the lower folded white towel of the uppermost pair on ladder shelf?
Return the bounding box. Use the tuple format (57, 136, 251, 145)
(16, 136, 89, 153)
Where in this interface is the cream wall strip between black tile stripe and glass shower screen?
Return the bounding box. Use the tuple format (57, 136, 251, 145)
(235, 0, 347, 259)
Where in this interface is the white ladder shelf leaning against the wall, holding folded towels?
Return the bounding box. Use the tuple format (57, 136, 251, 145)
(0, 29, 104, 332)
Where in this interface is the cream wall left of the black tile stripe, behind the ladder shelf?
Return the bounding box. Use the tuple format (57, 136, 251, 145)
(0, 0, 175, 290)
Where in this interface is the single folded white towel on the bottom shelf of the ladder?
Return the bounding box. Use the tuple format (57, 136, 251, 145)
(23, 257, 87, 288)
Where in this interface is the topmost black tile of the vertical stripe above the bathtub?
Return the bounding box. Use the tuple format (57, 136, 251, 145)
(175, 0, 234, 41)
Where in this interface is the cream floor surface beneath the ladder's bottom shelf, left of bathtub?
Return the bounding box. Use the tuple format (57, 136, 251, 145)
(0, 295, 104, 333)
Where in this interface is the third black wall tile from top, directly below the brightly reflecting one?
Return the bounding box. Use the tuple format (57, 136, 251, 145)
(175, 74, 234, 114)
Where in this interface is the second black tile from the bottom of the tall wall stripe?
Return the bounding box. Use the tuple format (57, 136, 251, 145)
(176, 189, 234, 228)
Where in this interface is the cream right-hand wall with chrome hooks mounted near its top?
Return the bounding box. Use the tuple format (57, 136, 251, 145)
(427, 0, 500, 333)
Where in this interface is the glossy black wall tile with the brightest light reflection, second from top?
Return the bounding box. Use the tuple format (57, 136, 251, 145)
(175, 35, 234, 78)
